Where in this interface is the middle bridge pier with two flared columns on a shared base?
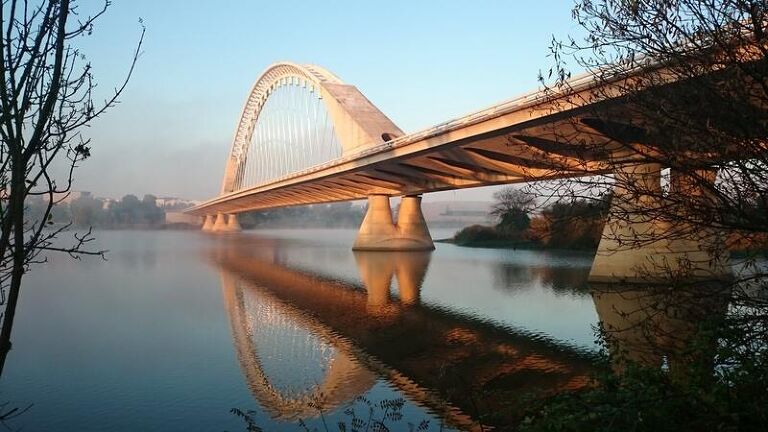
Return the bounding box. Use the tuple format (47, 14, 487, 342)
(352, 195, 435, 251)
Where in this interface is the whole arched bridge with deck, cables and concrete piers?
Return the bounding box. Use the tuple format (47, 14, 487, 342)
(187, 63, 730, 281)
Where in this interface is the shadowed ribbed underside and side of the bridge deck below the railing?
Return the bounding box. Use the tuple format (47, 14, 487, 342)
(190, 109, 612, 216)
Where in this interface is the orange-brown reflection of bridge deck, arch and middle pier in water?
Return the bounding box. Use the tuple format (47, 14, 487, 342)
(216, 238, 591, 429)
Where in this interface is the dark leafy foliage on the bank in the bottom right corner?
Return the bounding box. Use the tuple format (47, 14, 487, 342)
(519, 314, 768, 432)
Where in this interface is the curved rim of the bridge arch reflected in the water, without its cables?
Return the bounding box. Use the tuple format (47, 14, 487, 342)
(221, 271, 376, 420)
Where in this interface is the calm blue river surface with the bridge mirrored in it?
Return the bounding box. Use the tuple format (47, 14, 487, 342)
(0, 230, 598, 431)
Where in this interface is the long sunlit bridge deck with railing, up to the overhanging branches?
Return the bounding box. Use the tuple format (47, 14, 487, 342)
(187, 71, 626, 216)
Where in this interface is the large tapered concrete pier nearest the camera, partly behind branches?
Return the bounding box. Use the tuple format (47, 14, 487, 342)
(589, 164, 730, 283)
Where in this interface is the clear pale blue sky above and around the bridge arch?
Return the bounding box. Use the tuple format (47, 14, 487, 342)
(74, 0, 579, 201)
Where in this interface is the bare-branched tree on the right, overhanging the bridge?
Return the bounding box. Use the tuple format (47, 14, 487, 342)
(524, 0, 768, 372)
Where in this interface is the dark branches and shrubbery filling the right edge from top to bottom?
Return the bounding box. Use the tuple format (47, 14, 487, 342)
(521, 0, 768, 431)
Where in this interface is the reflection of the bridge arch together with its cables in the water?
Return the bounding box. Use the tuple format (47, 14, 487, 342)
(221, 272, 376, 420)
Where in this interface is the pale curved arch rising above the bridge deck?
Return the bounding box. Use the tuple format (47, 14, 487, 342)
(221, 63, 403, 195)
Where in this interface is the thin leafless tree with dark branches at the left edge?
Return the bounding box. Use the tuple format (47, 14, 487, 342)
(0, 0, 144, 371)
